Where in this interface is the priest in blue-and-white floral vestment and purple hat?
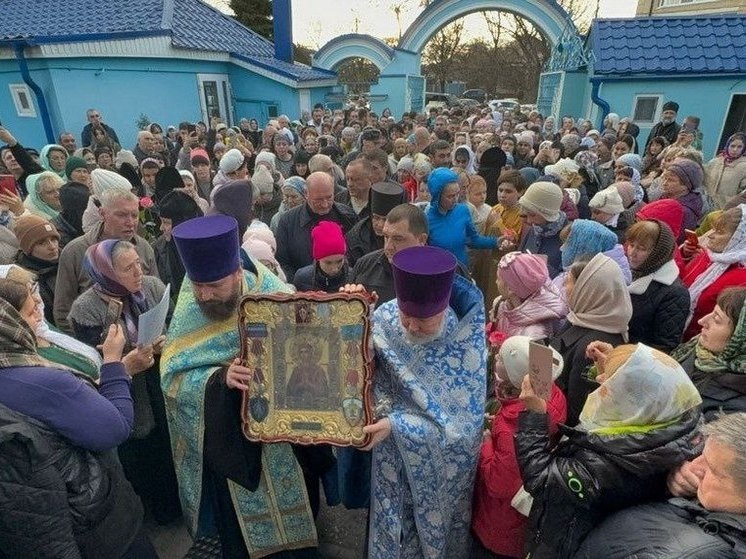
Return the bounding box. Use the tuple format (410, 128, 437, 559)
(365, 246, 487, 558)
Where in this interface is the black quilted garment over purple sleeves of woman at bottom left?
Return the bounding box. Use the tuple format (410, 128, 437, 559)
(0, 404, 143, 559)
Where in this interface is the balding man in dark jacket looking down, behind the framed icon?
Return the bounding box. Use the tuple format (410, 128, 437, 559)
(275, 171, 357, 278)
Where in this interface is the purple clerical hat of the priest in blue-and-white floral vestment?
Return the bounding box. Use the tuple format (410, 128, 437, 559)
(391, 246, 456, 318)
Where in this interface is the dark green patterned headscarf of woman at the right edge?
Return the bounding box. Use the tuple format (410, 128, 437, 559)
(671, 298, 746, 374)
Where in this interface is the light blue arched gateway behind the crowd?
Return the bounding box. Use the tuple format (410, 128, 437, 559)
(313, 0, 582, 115)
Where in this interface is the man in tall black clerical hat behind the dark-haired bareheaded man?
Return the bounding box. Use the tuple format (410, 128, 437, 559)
(345, 180, 405, 266)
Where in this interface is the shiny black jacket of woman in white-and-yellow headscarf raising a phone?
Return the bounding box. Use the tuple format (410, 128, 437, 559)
(515, 410, 702, 559)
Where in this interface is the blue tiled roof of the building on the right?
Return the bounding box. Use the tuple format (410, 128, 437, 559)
(591, 15, 746, 75)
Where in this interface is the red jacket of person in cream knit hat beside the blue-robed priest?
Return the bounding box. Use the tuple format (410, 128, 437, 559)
(471, 385, 567, 557)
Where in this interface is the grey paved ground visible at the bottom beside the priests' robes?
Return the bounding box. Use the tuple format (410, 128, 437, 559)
(146, 499, 368, 559)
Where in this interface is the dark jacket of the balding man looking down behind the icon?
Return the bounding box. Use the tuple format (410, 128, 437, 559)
(275, 202, 357, 278)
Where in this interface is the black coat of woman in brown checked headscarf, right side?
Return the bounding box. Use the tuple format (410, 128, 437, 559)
(629, 279, 690, 353)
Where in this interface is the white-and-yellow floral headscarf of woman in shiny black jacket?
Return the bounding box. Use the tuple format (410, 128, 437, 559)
(579, 344, 702, 435)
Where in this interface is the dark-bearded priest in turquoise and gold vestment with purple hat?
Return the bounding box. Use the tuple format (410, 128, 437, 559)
(161, 215, 317, 557)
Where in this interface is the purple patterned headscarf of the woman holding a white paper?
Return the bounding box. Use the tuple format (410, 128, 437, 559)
(83, 239, 148, 345)
